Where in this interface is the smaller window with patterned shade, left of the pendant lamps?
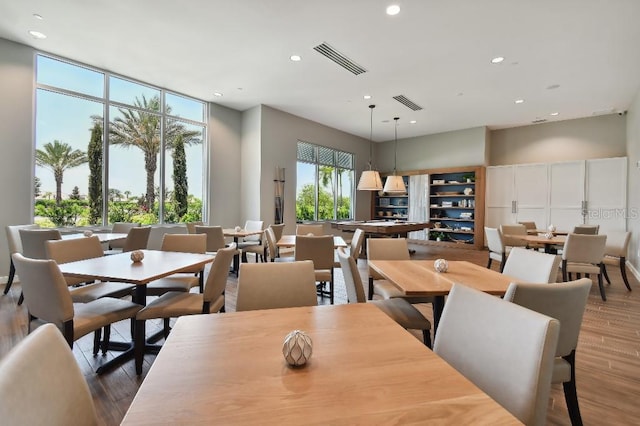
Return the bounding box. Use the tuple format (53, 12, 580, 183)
(296, 141, 355, 221)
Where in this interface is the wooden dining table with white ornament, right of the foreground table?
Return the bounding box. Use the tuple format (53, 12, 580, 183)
(369, 260, 522, 337)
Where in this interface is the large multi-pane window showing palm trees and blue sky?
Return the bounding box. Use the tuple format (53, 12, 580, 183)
(34, 55, 207, 226)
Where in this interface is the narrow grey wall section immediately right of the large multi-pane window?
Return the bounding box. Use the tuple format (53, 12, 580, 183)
(204, 103, 242, 228)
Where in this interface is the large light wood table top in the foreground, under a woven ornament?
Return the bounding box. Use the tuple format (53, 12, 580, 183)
(122, 303, 519, 425)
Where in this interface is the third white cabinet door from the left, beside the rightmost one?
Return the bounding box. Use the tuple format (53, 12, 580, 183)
(549, 161, 585, 231)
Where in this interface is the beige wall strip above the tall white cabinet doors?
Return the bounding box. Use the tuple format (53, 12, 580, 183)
(489, 114, 627, 166)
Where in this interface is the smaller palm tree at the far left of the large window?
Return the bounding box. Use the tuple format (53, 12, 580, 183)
(36, 140, 89, 204)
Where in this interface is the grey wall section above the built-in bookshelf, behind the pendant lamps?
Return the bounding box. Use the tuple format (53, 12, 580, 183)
(374, 127, 486, 172)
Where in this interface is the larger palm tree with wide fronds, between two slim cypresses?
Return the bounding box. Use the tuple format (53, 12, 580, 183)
(92, 95, 202, 210)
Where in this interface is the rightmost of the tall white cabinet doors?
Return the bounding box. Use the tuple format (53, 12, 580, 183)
(586, 157, 627, 234)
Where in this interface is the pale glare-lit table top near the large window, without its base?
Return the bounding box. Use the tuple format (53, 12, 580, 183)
(59, 250, 214, 285)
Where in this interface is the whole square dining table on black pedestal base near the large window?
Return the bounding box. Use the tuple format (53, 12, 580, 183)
(59, 250, 214, 374)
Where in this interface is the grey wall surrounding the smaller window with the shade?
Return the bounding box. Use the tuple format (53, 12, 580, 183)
(258, 106, 371, 233)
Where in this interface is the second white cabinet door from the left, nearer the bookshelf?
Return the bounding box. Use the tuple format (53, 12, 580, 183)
(514, 164, 549, 229)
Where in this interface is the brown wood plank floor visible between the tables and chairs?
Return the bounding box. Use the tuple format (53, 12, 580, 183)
(0, 245, 640, 425)
